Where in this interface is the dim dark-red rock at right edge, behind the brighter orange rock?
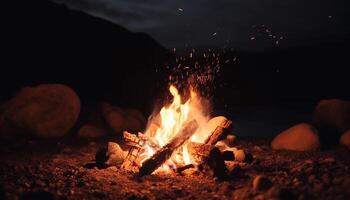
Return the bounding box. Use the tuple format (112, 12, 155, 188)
(313, 99, 350, 132)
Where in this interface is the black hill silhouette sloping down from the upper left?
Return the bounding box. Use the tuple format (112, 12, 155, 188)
(1, 0, 168, 113)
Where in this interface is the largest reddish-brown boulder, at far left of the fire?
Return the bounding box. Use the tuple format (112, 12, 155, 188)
(0, 84, 80, 138)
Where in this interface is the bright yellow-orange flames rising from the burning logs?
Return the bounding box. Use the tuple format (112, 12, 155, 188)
(141, 85, 209, 171)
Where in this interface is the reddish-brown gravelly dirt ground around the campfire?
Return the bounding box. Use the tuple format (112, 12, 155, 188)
(0, 138, 350, 199)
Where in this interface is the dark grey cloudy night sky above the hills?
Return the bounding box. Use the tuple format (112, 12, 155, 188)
(56, 0, 350, 50)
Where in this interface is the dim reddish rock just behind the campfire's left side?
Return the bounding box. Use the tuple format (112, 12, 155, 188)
(102, 104, 146, 134)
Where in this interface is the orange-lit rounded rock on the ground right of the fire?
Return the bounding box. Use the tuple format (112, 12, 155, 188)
(271, 123, 320, 151)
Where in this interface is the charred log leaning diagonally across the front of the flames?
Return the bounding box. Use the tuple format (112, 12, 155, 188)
(138, 120, 198, 176)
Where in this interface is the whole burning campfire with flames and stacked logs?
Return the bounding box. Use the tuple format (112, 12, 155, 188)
(98, 85, 241, 177)
